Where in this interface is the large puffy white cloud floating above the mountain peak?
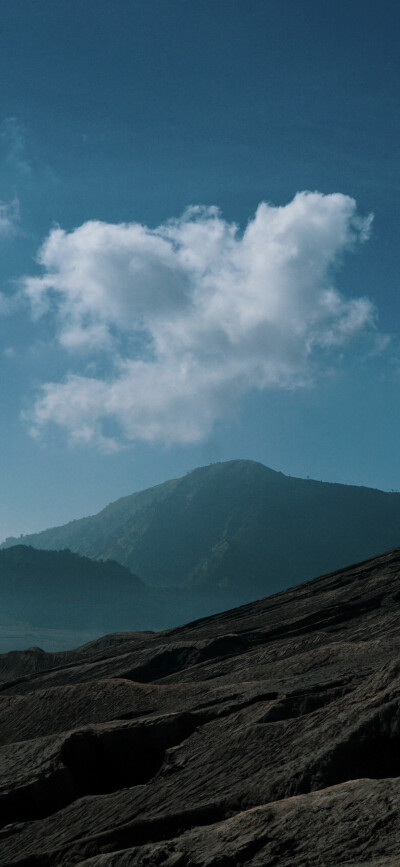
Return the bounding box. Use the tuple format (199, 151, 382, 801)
(24, 192, 375, 449)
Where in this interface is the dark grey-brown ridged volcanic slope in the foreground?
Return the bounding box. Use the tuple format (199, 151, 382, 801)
(0, 550, 400, 867)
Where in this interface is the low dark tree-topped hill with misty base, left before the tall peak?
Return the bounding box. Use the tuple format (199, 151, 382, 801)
(0, 545, 241, 652)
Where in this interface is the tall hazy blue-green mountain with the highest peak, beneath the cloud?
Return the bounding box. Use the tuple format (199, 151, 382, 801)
(4, 461, 400, 608)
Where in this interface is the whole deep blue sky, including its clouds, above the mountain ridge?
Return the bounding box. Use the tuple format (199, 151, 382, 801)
(0, 0, 400, 539)
